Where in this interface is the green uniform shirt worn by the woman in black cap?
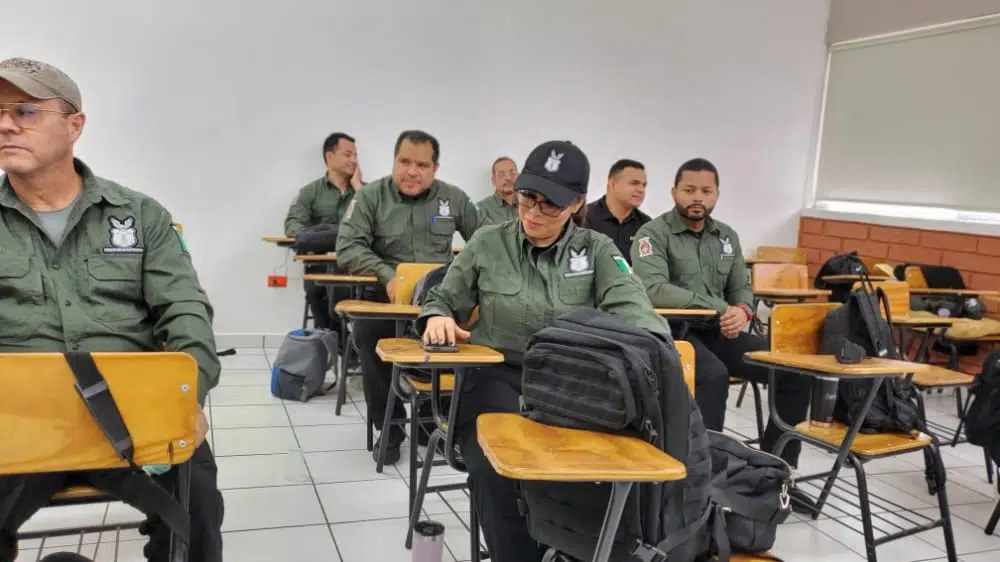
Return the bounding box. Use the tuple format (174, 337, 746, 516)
(418, 221, 669, 364)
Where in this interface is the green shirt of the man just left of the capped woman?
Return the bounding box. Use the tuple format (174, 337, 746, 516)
(337, 176, 479, 284)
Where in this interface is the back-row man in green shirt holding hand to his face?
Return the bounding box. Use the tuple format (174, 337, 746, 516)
(285, 133, 363, 330)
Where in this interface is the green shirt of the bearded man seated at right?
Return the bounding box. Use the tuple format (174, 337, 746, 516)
(632, 209, 753, 314)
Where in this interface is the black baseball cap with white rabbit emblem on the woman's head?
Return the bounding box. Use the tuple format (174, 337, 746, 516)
(514, 141, 590, 207)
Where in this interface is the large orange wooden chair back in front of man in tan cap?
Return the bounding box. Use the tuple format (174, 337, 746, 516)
(0, 352, 198, 475)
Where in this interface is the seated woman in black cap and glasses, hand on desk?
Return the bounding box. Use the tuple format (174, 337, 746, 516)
(418, 141, 669, 562)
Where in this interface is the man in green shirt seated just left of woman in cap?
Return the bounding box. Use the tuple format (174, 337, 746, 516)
(337, 131, 479, 464)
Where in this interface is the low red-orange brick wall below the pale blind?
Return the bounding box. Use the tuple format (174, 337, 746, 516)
(799, 217, 1000, 372)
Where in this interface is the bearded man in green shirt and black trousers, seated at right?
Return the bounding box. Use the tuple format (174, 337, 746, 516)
(632, 158, 810, 467)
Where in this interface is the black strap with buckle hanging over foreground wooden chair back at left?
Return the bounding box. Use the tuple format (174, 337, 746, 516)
(63, 351, 191, 543)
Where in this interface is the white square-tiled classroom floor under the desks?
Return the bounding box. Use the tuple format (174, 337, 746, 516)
(18, 349, 1000, 562)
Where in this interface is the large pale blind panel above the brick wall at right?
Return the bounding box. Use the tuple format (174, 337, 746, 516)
(816, 17, 1000, 212)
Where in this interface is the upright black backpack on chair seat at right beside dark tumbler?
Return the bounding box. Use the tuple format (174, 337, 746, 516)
(822, 275, 926, 433)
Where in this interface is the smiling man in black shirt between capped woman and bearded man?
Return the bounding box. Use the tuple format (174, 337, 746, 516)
(586, 159, 651, 263)
